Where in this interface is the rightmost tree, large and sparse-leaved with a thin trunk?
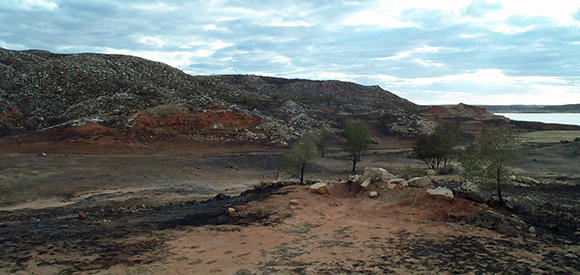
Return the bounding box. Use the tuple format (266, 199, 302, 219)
(461, 126, 522, 204)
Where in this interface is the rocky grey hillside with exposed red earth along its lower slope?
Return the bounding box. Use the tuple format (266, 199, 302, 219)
(0, 48, 432, 145)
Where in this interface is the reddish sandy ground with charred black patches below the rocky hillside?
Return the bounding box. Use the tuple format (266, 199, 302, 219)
(0, 139, 580, 274)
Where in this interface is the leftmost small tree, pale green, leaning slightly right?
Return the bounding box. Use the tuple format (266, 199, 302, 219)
(283, 135, 316, 184)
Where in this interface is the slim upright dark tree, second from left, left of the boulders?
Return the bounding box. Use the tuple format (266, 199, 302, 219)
(344, 121, 371, 175)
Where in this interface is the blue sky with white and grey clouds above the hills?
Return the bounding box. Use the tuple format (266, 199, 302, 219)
(0, 0, 580, 105)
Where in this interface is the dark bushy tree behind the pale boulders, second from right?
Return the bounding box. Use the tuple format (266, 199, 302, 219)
(413, 122, 461, 170)
